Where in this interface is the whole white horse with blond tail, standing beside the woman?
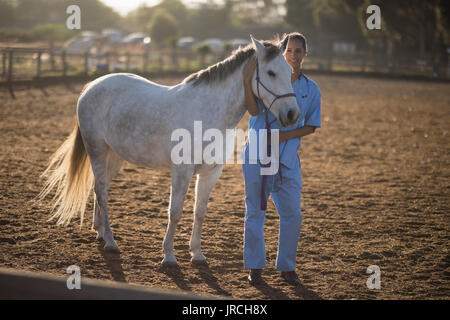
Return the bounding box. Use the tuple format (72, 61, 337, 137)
(40, 37, 299, 264)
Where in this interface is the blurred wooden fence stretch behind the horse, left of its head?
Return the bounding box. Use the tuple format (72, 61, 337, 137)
(0, 48, 208, 81)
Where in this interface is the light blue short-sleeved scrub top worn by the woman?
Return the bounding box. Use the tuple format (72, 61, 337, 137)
(243, 75, 322, 168)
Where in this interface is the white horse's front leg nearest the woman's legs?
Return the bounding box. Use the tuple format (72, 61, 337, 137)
(189, 165, 223, 264)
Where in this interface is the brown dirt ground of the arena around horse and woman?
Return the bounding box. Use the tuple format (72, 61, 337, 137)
(0, 75, 450, 299)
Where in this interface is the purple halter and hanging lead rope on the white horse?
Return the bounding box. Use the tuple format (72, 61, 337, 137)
(256, 59, 297, 211)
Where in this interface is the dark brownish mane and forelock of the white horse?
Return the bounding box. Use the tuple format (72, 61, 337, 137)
(183, 41, 281, 86)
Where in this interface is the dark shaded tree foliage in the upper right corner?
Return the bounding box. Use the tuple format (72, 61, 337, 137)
(285, 0, 450, 56)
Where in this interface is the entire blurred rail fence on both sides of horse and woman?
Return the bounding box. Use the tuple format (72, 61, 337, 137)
(0, 47, 449, 95)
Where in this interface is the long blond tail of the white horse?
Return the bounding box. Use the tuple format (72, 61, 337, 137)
(38, 121, 94, 227)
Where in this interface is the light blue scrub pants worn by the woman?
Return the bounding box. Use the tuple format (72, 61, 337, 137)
(242, 161, 302, 271)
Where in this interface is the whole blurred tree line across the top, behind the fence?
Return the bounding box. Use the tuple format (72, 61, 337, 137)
(0, 0, 450, 62)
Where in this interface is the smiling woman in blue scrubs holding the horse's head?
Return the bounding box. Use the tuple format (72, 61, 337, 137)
(242, 32, 321, 286)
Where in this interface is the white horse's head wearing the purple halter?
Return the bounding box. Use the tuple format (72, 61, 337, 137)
(251, 37, 300, 127)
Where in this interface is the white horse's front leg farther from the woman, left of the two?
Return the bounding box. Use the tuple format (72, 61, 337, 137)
(161, 165, 194, 265)
